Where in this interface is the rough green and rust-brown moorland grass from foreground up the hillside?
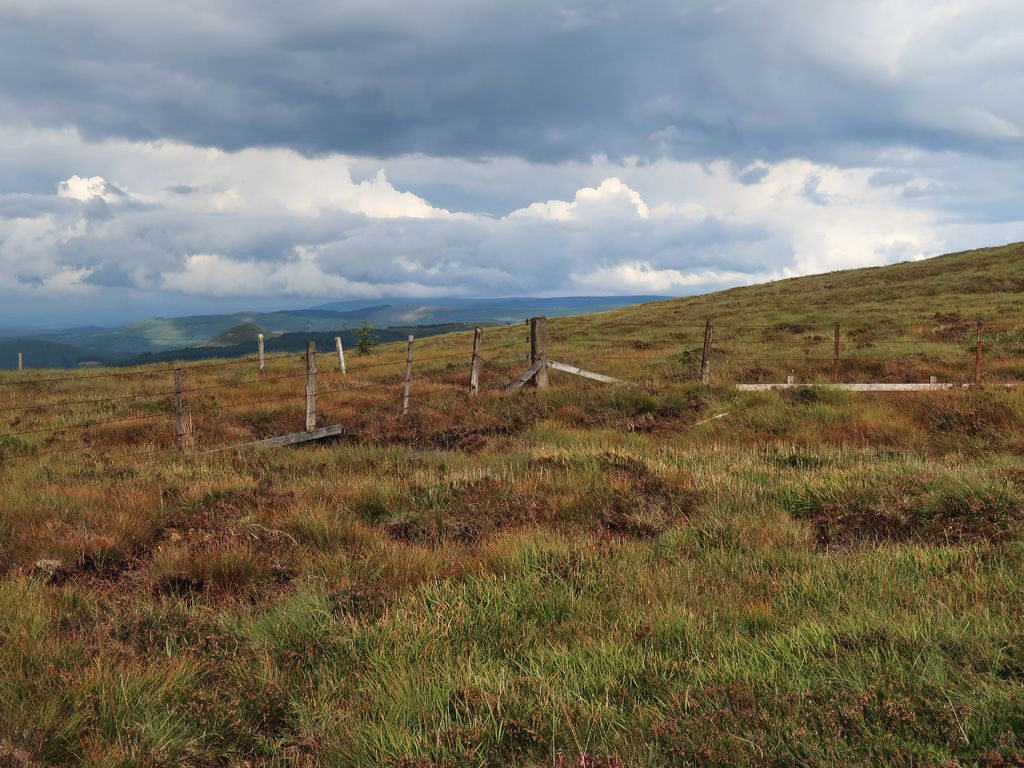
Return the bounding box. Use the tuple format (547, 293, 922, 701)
(0, 247, 1024, 768)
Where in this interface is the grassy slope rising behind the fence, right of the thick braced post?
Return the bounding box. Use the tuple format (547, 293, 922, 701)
(551, 244, 1024, 382)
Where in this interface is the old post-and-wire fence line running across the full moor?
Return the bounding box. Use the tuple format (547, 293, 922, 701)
(0, 318, 1024, 462)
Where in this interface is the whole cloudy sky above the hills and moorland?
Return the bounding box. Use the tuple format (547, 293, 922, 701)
(0, 0, 1024, 327)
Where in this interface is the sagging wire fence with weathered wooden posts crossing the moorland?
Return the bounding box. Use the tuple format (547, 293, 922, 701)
(0, 318, 1024, 463)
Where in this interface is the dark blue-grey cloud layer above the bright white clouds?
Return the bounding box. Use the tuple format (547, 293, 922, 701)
(0, 0, 1019, 162)
